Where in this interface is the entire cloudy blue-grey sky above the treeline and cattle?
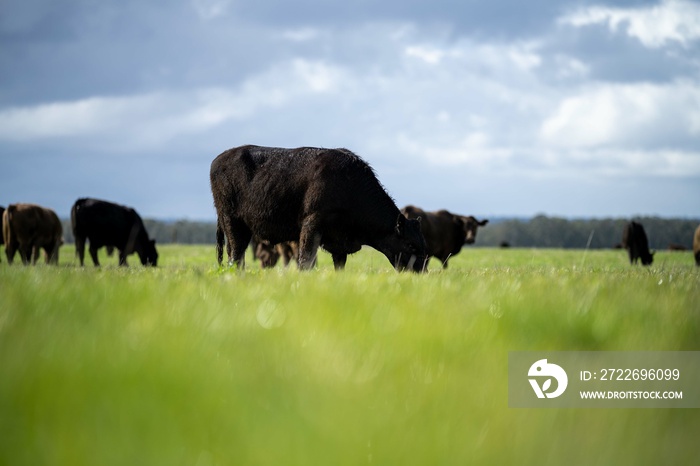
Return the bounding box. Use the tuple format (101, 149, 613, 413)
(0, 0, 700, 219)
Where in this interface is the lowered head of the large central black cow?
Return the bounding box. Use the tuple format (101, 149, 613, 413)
(386, 214, 428, 272)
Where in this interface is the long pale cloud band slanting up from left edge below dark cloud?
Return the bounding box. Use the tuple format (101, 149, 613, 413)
(0, 59, 343, 148)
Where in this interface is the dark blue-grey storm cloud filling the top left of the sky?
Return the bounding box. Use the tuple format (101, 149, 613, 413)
(0, 0, 283, 105)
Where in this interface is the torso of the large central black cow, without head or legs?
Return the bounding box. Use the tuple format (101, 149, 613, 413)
(210, 146, 399, 244)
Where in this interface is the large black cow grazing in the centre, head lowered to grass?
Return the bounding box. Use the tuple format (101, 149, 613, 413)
(210, 146, 425, 271)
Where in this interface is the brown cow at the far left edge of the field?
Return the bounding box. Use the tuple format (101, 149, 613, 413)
(2, 204, 63, 265)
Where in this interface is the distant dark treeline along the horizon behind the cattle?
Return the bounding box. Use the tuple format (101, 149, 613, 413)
(63, 215, 700, 250)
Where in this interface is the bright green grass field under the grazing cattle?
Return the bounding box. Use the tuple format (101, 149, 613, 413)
(0, 246, 700, 466)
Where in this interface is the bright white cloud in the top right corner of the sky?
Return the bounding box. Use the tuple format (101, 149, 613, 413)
(559, 0, 700, 48)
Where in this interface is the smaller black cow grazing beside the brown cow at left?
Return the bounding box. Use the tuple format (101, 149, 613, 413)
(71, 198, 158, 267)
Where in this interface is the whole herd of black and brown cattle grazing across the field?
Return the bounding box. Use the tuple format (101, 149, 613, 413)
(0, 146, 700, 272)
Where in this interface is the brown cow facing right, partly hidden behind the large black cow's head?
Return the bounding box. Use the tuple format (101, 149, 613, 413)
(401, 205, 488, 268)
